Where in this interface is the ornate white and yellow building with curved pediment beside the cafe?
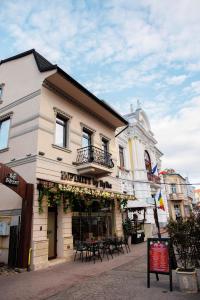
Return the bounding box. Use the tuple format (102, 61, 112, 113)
(116, 103, 167, 237)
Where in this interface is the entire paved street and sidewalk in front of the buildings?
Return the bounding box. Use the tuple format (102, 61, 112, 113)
(0, 243, 200, 300)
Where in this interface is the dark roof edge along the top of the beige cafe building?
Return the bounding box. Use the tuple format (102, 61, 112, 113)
(0, 49, 129, 125)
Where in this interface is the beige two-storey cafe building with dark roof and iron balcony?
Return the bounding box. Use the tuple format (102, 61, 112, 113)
(0, 50, 128, 269)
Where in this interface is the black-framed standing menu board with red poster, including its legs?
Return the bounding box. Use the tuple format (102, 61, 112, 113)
(147, 238, 172, 291)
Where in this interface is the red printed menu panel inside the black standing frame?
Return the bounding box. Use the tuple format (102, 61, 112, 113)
(149, 241, 169, 273)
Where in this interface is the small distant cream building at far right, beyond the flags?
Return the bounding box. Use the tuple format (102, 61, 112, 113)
(162, 169, 193, 220)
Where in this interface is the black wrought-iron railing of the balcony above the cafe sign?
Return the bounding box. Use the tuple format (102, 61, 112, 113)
(76, 146, 114, 169)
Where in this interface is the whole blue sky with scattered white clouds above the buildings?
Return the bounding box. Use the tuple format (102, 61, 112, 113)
(0, 0, 200, 183)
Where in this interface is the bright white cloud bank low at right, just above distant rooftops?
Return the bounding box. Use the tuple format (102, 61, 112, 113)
(152, 96, 200, 182)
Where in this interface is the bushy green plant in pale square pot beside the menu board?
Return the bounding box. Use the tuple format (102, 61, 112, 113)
(167, 215, 200, 293)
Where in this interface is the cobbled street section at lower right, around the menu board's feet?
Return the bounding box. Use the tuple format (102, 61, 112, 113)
(46, 255, 200, 300)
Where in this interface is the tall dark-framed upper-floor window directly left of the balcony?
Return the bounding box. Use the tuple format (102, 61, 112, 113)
(55, 114, 68, 148)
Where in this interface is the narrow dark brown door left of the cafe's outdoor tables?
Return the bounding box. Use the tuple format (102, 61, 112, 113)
(47, 207, 57, 259)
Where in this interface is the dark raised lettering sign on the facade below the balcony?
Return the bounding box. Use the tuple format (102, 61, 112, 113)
(61, 171, 112, 189)
